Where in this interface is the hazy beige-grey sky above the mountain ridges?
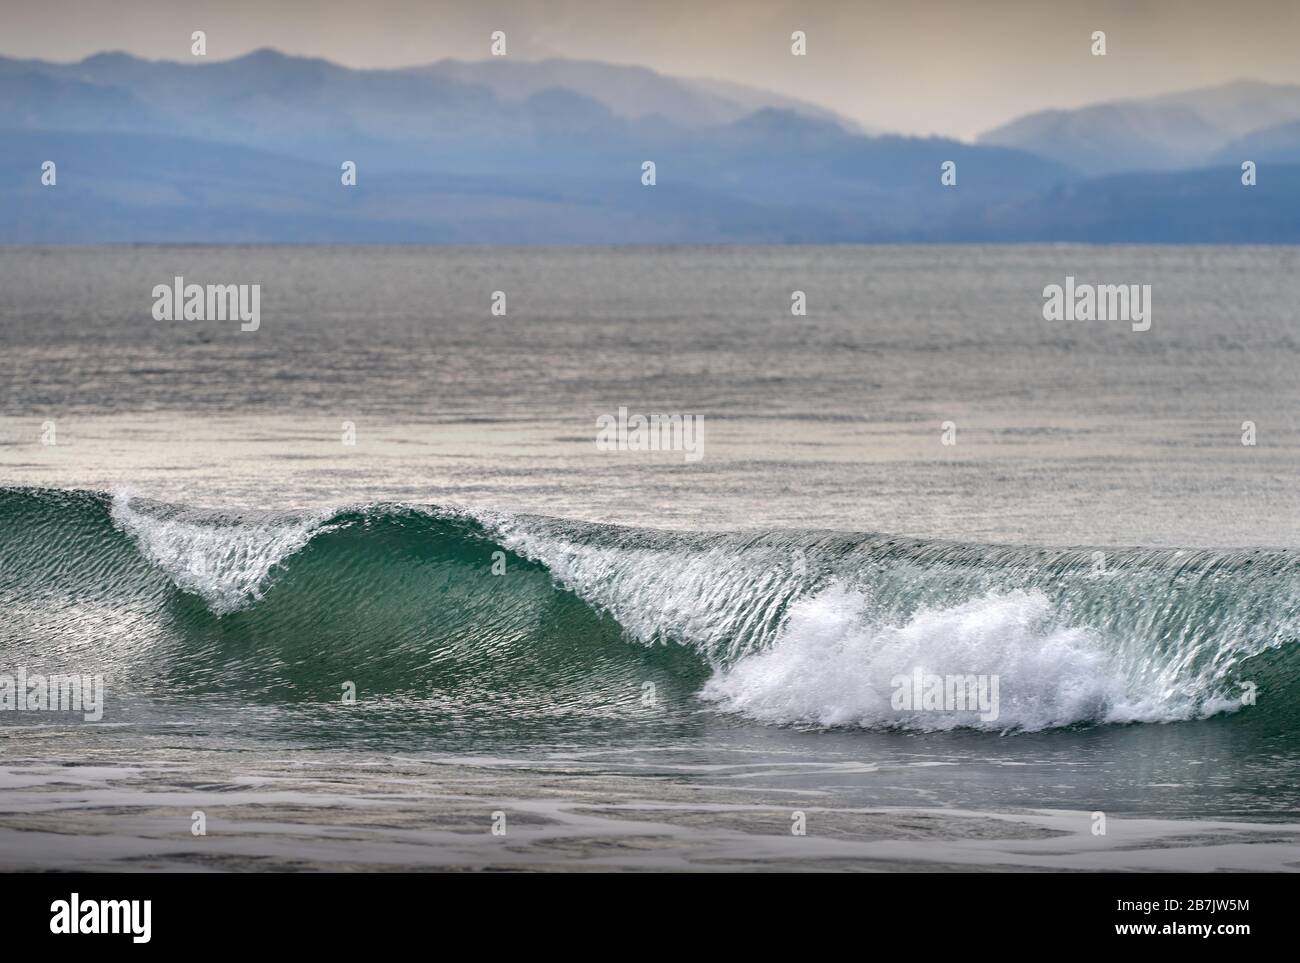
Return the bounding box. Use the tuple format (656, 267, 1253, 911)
(0, 0, 1300, 138)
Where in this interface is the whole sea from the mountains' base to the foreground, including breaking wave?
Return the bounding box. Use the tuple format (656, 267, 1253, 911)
(0, 246, 1300, 871)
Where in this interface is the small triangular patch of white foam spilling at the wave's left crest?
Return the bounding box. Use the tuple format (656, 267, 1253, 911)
(112, 490, 328, 615)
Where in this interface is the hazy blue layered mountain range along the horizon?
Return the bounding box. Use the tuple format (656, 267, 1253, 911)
(0, 51, 1300, 244)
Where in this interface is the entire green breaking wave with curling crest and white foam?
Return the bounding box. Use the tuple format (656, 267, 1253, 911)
(0, 489, 1300, 732)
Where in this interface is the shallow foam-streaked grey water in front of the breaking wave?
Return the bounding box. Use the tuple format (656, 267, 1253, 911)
(0, 738, 1300, 872)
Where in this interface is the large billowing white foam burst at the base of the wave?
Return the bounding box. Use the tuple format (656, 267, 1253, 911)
(702, 584, 1227, 732)
